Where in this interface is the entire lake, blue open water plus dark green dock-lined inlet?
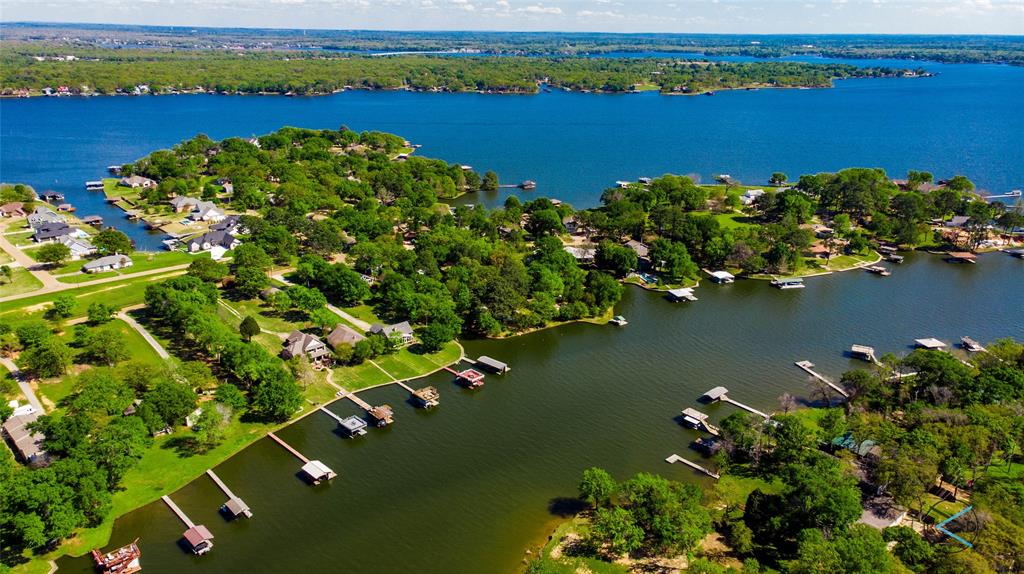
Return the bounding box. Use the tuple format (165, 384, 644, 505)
(0, 54, 1024, 574)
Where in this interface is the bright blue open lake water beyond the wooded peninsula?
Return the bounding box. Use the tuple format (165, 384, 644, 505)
(0, 57, 1024, 249)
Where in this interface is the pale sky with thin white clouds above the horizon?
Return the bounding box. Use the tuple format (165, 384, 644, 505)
(0, 0, 1024, 35)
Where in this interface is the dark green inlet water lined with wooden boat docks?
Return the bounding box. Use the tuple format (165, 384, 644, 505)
(59, 254, 1024, 574)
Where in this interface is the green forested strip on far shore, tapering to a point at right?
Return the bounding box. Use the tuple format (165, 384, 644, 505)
(0, 44, 923, 95)
